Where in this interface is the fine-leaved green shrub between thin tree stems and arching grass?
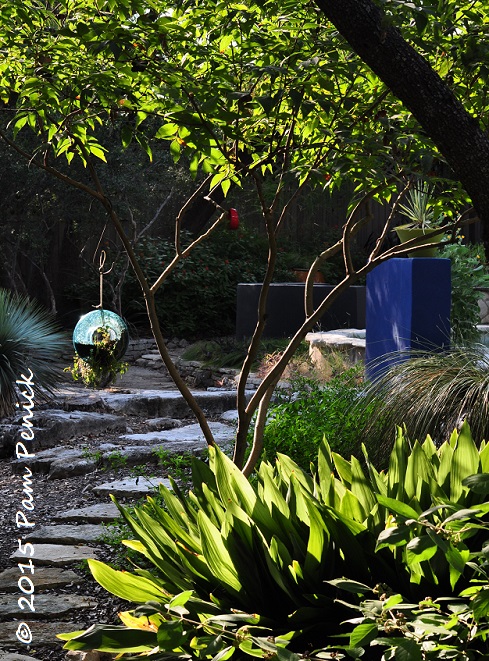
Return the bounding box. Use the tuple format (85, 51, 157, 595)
(263, 367, 369, 470)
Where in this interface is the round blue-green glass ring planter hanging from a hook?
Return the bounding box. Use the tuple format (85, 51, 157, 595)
(73, 310, 129, 360)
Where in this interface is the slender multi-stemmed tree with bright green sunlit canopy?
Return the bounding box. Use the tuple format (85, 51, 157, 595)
(0, 0, 472, 474)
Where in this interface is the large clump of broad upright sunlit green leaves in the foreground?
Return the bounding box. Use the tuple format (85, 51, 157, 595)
(59, 426, 489, 660)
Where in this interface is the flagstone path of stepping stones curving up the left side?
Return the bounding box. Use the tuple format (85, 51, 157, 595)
(0, 368, 244, 661)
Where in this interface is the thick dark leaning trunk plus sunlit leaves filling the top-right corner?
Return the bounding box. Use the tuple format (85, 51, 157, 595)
(315, 0, 489, 251)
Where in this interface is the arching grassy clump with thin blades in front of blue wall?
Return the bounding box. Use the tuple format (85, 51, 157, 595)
(357, 344, 489, 464)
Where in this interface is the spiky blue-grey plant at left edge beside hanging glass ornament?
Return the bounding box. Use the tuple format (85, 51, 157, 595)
(0, 289, 68, 417)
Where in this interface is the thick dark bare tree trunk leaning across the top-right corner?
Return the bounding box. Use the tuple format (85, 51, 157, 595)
(315, 0, 489, 254)
